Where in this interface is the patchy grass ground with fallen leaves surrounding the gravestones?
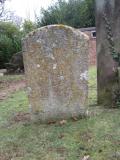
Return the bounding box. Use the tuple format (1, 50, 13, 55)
(0, 67, 120, 160)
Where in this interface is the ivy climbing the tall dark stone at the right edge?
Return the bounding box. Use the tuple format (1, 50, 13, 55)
(103, 4, 120, 107)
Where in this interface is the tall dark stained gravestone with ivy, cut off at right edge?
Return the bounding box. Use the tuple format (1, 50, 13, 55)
(96, 0, 120, 106)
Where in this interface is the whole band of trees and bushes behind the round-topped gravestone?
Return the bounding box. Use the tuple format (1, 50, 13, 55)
(0, 0, 95, 68)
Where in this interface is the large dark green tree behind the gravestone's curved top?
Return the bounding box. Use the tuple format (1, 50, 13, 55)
(37, 0, 95, 28)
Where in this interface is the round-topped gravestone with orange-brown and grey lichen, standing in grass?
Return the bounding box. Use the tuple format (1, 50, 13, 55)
(23, 25, 88, 122)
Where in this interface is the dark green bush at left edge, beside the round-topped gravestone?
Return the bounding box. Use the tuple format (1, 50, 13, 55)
(0, 22, 22, 68)
